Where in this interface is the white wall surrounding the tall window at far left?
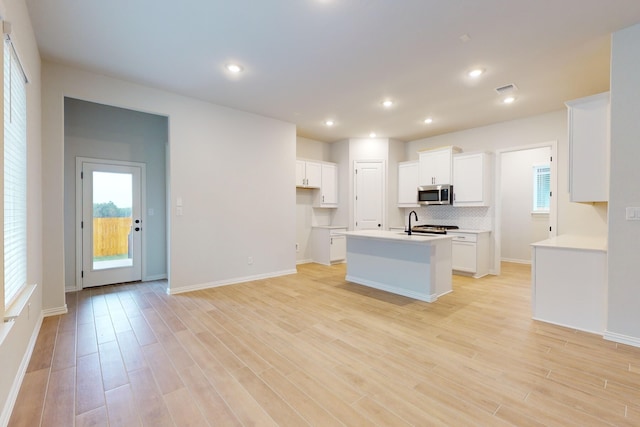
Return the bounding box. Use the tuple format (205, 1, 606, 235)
(0, 0, 46, 425)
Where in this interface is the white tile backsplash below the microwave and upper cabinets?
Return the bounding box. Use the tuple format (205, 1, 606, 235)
(404, 206, 493, 230)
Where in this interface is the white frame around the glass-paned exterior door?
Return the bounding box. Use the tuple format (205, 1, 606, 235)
(75, 157, 147, 291)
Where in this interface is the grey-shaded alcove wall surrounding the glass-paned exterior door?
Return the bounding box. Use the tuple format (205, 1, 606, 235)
(64, 98, 169, 289)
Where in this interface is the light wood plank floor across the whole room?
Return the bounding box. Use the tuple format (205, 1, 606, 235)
(10, 264, 640, 427)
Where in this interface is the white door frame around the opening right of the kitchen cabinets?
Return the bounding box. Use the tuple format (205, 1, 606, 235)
(493, 140, 559, 275)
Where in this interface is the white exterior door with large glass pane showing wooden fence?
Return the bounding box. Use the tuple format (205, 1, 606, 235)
(78, 161, 143, 288)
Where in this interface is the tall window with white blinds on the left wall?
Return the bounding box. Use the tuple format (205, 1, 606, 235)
(3, 33, 27, 308)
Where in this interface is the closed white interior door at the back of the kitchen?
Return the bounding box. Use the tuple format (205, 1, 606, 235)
(355, 162, 384, 230)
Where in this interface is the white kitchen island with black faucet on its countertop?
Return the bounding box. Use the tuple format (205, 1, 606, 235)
(344, 230, 452, 302)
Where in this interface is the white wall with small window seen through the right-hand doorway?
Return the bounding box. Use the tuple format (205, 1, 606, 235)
(499, 147, 551, 263)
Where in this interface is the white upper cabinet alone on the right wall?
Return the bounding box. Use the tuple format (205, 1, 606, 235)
(566, 92, 610, 202)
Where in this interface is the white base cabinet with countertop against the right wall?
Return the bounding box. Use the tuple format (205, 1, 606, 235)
(531, 235, 607, 334)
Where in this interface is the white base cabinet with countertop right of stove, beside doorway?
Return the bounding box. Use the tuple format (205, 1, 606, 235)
(447, 231, 491, 278)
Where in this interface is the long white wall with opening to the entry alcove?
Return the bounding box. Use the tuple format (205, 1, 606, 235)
(43, 63, 296, 300)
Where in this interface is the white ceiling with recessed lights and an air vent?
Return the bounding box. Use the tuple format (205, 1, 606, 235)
(22, 0, 640, 142)
